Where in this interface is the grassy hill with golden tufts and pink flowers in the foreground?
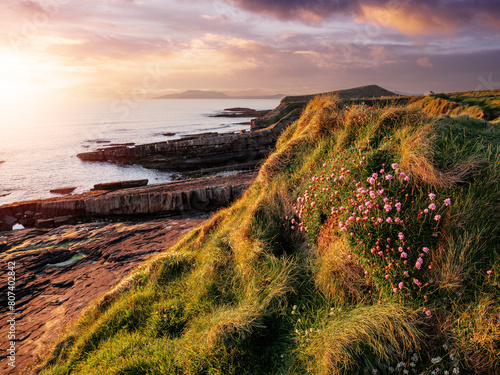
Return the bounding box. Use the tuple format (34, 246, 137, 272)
(37, 89, 500, 375)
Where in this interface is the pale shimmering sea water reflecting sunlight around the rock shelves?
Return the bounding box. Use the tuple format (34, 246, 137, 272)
(0, 99, 279, 205)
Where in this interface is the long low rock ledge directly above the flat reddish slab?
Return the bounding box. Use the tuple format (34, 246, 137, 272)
(0, 173, 254, 231)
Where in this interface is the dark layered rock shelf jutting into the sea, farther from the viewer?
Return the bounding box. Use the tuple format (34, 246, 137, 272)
(77, 98, 307, 174)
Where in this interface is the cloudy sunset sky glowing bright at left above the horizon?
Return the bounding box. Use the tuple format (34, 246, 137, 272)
(0, 0, 500, 100)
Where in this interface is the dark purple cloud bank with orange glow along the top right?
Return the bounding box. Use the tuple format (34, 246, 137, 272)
(223, 0, 500, 35)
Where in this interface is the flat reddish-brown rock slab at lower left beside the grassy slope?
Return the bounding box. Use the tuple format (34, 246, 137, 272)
(0, 216, 206, 374)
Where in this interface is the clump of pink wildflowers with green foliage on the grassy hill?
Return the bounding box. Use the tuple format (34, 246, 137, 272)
(291, 150, 451, 316)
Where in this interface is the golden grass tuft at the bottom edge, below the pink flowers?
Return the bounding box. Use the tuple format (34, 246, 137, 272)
(304, 304, 422, 375)
